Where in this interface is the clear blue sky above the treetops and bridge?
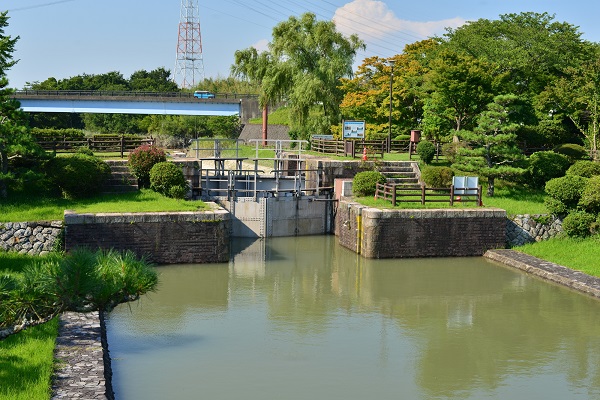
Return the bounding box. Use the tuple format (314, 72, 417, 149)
(0, 0, 600, 89)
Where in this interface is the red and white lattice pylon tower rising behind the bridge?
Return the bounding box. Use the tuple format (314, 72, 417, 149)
(173, 0, 204, 89)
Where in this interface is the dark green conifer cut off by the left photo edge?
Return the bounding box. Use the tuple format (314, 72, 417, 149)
(0, 11, 34, 198)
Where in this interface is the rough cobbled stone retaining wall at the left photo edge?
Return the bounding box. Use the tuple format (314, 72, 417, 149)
(0, 221, 63, 255)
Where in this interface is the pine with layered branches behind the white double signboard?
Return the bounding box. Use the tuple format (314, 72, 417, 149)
(452, 95, 524, 197)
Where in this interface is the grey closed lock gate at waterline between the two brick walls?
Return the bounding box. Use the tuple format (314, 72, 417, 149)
(220, 196, 333, 237)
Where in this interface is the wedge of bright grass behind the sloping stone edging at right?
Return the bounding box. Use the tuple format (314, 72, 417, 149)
(513, 235, 600, 277)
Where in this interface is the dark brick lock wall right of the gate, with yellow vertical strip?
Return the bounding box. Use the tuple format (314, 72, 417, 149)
(335, 201, 507, 258)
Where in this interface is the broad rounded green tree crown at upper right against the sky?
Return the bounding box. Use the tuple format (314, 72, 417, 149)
(444, 12, 593, 100)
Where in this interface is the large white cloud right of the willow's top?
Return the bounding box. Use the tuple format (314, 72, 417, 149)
(333, 0, 466, 41)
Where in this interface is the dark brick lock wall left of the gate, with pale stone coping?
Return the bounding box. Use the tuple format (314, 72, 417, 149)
(65, 209, 230, 264)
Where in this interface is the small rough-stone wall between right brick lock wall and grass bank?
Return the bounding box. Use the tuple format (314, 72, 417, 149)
(506, 214, 563, 247)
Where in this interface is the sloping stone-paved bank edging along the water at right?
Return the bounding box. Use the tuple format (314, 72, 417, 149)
(483, 250, 600, 298)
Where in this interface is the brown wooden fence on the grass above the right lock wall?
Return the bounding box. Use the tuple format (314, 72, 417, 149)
(375, 183, 483, 206)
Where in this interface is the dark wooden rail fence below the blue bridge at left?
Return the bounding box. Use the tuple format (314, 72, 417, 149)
(37, 135, 154, 158)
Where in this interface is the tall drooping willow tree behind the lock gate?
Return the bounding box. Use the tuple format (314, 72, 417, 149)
(232, 13, 364, 138)
